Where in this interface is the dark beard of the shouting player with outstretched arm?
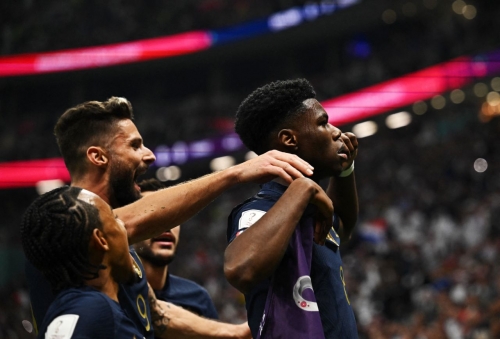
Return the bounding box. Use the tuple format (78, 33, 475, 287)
(109, 163, 141, 207)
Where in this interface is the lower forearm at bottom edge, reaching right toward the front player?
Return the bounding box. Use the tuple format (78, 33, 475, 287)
(149, 288, 252, 339)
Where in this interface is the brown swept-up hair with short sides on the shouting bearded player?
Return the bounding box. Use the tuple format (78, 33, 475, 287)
(54, 97, 134, 176)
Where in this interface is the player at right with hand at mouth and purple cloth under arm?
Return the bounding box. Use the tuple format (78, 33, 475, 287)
(224, 79, 358, 338)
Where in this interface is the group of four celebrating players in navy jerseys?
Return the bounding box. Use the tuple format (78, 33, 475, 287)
(21, 79, 358, 339)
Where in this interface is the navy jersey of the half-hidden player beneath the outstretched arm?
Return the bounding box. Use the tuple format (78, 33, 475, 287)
(155, 273, 219, 319)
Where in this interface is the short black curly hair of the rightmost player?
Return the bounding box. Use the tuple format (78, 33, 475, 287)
(234, 79, 316, 154)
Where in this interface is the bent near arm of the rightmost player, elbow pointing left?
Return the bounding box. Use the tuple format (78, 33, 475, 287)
(224, 178, 333, 293)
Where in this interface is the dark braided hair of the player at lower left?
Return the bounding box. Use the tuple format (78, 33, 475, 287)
(21, 186, 104, 292)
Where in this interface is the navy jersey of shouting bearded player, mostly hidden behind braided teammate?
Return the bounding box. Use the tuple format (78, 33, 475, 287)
(26, 247, 154, 339)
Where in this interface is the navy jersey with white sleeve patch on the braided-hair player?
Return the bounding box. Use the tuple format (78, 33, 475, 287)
(38, 287, 143, 339)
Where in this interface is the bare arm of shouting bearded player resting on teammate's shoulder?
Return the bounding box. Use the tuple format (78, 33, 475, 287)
(115, 151, 312, 244)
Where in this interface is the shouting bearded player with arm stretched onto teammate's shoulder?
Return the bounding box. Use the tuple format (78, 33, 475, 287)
(26, 97, 313, 338)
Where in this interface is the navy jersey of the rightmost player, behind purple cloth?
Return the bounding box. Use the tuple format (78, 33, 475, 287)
(227, 182, 358, 339)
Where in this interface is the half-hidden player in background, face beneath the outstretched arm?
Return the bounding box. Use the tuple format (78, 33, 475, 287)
(134, 179, 251, 338)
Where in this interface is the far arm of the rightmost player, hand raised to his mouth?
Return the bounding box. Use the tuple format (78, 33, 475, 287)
(326, 132, 359, 242)
